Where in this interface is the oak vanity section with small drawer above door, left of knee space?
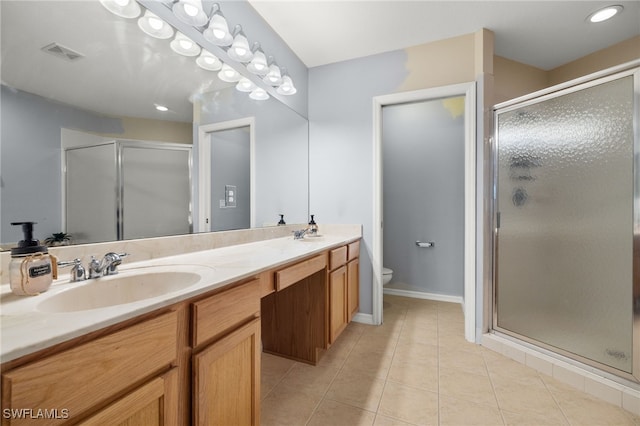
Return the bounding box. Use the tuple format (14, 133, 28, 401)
(192, 279, 262, 426)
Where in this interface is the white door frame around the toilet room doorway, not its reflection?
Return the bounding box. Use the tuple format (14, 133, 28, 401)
(371, 82, 476, 342)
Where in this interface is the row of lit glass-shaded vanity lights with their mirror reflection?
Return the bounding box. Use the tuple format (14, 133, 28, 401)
(100, 0, 297, 100)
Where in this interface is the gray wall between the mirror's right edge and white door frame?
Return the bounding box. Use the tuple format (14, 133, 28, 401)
(309, 51, 408, 314)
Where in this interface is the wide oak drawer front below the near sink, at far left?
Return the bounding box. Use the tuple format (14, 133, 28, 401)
(2, 311, 178, 419)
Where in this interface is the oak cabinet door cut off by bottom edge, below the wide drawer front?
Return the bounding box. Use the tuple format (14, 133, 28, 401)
(79, 368, 178, 426)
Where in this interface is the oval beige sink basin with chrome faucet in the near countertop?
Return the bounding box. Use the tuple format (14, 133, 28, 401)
(37, 265, 211, 313)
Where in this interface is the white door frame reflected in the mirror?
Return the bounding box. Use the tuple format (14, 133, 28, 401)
(198, 117, 256, 232)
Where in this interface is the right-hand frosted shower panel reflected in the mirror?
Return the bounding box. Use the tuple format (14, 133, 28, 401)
(121, 146, 191, 239)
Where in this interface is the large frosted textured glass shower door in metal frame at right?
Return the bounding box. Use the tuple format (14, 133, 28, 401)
(493, 64, 640, 381)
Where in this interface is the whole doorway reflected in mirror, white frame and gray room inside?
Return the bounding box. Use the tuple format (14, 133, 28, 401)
(198, 118, 254, 232)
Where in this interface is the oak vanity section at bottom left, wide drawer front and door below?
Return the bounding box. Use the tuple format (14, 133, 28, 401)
(2, 311, 179, 425)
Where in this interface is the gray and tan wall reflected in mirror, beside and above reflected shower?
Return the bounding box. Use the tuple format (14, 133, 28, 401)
(0, 85, 192, 243)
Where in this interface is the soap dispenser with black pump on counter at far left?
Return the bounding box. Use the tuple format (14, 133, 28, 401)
(9, 222, 58, 296)
